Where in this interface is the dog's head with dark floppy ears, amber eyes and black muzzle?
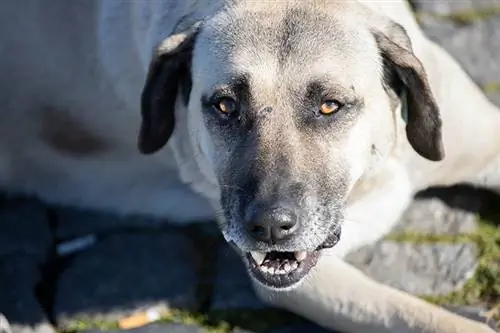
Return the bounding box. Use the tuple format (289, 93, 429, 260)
(140, 3, 442, 288)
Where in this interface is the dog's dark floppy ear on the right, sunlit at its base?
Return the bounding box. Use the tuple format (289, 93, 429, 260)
(372, 23, 444, 161)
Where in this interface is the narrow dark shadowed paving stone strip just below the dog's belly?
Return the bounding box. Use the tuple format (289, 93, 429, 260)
(55, 207, 168, 239)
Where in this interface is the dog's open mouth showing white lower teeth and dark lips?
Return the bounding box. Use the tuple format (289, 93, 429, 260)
(244, 227, 341, 289)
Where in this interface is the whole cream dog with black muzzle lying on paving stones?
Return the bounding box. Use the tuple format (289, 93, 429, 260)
(0, 0, 500, 333)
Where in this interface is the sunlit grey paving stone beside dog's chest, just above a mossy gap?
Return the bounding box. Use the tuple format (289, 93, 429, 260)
(394, 195, 481, 235)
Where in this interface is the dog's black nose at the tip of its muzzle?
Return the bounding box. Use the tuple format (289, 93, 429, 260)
(247, 208, 299, 244)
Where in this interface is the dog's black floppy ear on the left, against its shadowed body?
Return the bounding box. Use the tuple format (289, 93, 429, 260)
(138, 23, 200, 154)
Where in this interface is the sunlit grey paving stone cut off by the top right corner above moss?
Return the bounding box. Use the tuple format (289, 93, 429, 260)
(410, 0, 500, 15)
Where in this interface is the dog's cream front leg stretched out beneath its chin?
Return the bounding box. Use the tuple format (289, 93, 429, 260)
(255, 253, 494, 333)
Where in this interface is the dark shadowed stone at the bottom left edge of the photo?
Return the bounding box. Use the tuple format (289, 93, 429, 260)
(0, 196, 54, 333)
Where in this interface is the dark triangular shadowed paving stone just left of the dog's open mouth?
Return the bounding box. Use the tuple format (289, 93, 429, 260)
(212, 244, 267, 310)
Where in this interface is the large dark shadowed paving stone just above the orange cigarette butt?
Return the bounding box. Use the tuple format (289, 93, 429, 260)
(54, 230, 197, 328)
